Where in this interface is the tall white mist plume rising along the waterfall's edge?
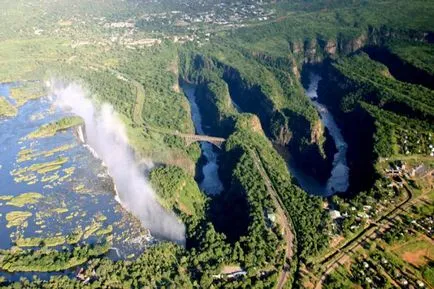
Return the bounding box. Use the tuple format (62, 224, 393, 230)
(54, 85, 185, 244)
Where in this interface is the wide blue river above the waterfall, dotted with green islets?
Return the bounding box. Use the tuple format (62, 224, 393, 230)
(0, 84, 153, 280)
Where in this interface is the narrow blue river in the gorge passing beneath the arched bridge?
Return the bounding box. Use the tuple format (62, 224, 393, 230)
(183, 85, 223, 195)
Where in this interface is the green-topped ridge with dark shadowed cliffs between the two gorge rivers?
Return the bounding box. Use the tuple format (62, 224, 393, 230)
(180, 44, 331, 181)
